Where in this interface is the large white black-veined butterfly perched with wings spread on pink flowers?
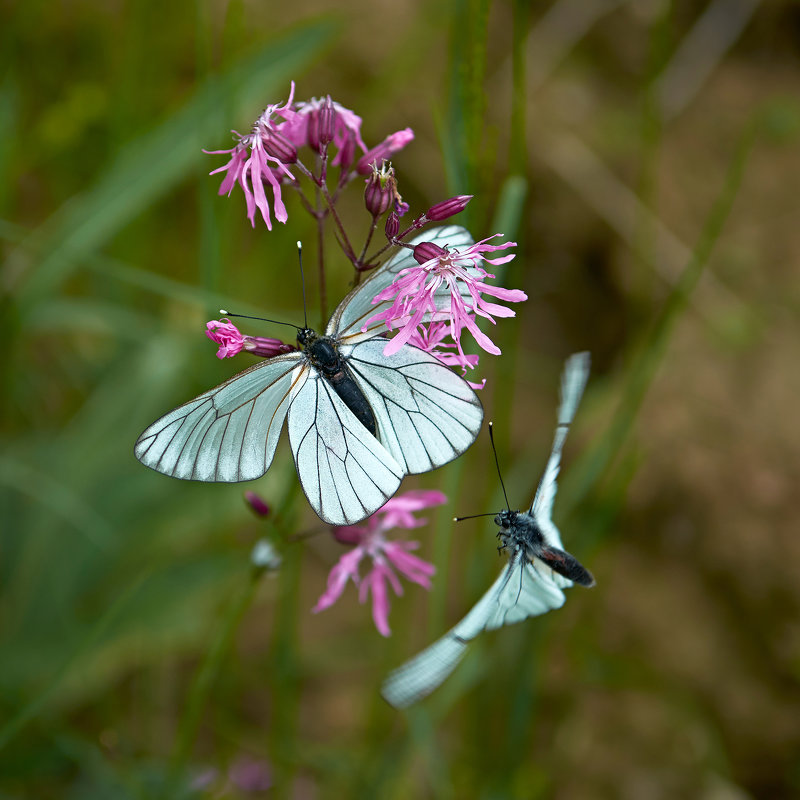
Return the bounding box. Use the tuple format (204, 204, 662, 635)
(134, 226, 483, 525)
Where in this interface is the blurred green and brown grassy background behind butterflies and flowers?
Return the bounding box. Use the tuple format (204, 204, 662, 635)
(0, 0, 800, 800)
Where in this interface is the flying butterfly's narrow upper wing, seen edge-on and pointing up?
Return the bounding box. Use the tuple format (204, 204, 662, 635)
(530, 353, 590, 524)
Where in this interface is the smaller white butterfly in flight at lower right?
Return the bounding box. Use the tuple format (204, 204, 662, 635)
(381, 353, 594, 708)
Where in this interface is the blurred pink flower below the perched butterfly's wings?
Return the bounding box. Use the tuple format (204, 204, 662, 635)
(312, 490, 447, 636)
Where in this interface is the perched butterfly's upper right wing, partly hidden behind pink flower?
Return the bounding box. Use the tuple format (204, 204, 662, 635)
(326, 225, 473, 344)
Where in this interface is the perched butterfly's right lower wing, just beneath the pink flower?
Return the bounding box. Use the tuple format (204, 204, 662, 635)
(340, 339, 483, 475)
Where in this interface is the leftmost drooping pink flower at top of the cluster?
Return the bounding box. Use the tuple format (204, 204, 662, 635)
(203, 81, 297, 230)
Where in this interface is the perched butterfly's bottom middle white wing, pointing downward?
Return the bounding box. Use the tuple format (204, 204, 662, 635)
(289, 370, 405, 525)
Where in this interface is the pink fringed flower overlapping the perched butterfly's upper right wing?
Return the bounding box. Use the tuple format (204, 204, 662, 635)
(364, 234, 528, 356)
